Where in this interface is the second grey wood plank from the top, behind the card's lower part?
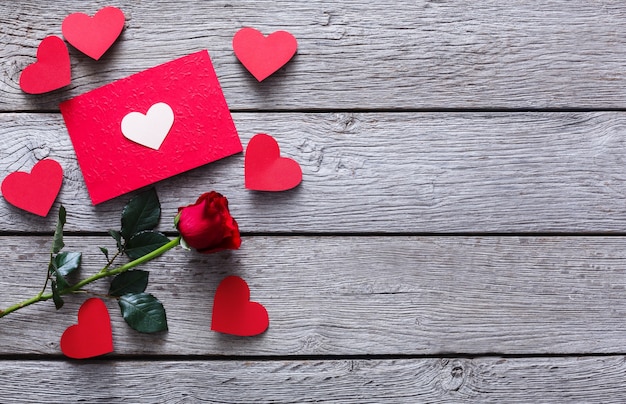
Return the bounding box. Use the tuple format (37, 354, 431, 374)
(0, 112, 626, 232)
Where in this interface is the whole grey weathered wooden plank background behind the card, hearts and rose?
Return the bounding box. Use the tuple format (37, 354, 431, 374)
(0, 0, 626, 403)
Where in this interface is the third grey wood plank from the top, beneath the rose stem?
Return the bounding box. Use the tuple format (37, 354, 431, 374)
(0, 236, 626, 356)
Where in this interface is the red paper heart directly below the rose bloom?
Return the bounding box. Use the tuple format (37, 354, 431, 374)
(211, 276, 270, 337)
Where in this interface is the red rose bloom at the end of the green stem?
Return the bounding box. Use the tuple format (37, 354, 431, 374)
(176, 191, 241, 254)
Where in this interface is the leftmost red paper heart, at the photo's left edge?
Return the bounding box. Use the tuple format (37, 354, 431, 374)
(0, 159, 63, 217)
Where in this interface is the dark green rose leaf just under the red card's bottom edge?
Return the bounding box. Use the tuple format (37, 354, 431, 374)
(121, 188, 161, 241)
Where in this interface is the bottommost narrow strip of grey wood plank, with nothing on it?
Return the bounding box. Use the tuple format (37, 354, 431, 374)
(0, 356, 626, 404)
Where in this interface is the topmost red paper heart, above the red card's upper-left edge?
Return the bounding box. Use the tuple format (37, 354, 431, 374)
(61, 7, 125, 60)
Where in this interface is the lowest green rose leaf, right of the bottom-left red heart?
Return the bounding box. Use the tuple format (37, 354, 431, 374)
(119, 293, 167, 333)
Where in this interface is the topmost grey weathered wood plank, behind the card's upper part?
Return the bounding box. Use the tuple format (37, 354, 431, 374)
(0, 0, 626, 111)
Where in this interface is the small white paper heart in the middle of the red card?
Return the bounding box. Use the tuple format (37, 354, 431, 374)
(122, 102, 174, 150)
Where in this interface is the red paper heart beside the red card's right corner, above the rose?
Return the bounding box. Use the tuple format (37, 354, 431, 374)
(244, 133, 302, 191)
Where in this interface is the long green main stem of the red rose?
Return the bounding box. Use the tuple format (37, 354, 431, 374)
(0, 236, 181, 318)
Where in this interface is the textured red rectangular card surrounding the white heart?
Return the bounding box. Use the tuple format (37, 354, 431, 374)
(60, 51, 242, 204)
